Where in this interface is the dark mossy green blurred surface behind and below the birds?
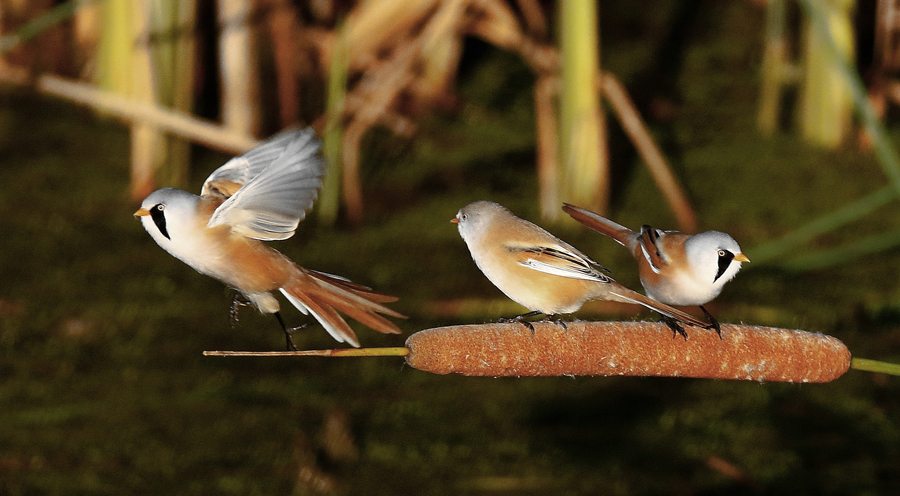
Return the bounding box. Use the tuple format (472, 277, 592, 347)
(0, 2, 900, 495)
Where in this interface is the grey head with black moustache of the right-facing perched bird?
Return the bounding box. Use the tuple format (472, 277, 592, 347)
(684, 231, 750, 284)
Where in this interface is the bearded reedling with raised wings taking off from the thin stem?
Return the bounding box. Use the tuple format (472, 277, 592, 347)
(134, 129, 405, 349)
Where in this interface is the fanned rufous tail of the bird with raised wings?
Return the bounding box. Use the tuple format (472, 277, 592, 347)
(280, 270, 406, 348)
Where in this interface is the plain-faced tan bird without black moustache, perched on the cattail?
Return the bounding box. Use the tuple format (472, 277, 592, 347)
(451, 201, 705, 332)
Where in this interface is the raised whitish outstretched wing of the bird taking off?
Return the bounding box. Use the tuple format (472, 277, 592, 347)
(201, 128, 325, 241)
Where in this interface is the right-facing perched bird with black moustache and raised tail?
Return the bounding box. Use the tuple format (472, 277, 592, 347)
(563, 203, 750, 336)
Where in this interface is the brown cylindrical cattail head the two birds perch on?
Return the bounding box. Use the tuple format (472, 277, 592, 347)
(406, 322, 850, 382)
